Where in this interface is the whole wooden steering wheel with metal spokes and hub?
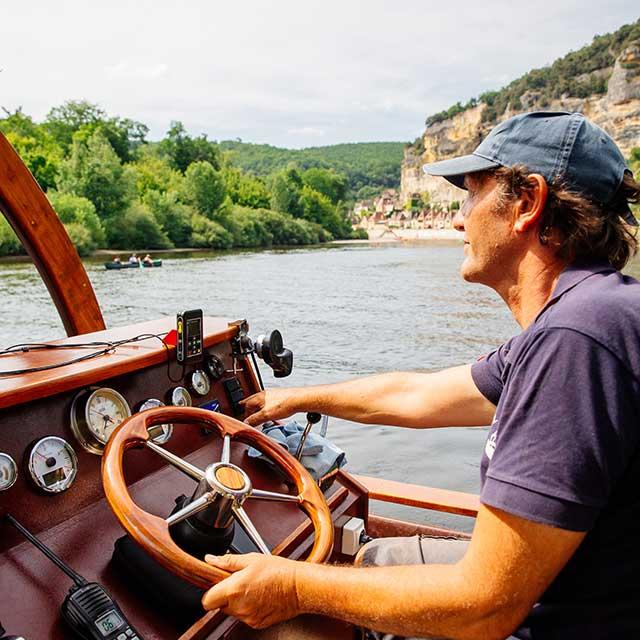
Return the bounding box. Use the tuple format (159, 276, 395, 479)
(102, 407, 333, 588)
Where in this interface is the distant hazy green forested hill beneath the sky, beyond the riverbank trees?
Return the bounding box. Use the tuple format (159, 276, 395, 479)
(220, 140, 404, 199)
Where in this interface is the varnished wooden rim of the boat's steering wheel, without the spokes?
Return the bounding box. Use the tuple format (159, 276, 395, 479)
(102, 407, 333, 588)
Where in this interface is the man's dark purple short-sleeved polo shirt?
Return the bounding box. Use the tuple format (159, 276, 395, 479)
(471, 262, 640, 640)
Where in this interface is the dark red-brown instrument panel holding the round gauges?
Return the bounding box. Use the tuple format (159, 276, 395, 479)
(0, 341, 255, 551)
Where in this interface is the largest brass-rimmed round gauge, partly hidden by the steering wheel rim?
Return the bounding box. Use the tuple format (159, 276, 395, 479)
(71, 387, 131, 455)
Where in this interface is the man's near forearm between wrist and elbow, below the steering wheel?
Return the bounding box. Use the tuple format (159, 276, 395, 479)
(296, 564, 511, 640)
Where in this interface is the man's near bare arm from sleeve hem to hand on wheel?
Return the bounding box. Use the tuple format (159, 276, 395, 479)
(203, 506, 585, 640)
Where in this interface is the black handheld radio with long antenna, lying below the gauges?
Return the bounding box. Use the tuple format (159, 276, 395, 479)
(5, 514, 142, 640)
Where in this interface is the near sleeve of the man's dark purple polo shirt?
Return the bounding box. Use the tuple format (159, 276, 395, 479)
(482, 329, 639, 531)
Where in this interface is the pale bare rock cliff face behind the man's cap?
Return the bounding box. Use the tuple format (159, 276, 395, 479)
(400, 42, 640, 204)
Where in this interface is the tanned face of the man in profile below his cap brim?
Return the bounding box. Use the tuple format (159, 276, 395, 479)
(453, 173, 516, 289)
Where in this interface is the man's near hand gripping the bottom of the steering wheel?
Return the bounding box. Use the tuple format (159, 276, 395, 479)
(202, 553, 300, 629)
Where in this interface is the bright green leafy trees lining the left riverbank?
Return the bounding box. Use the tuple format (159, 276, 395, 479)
(0, 101, 368, 256)
